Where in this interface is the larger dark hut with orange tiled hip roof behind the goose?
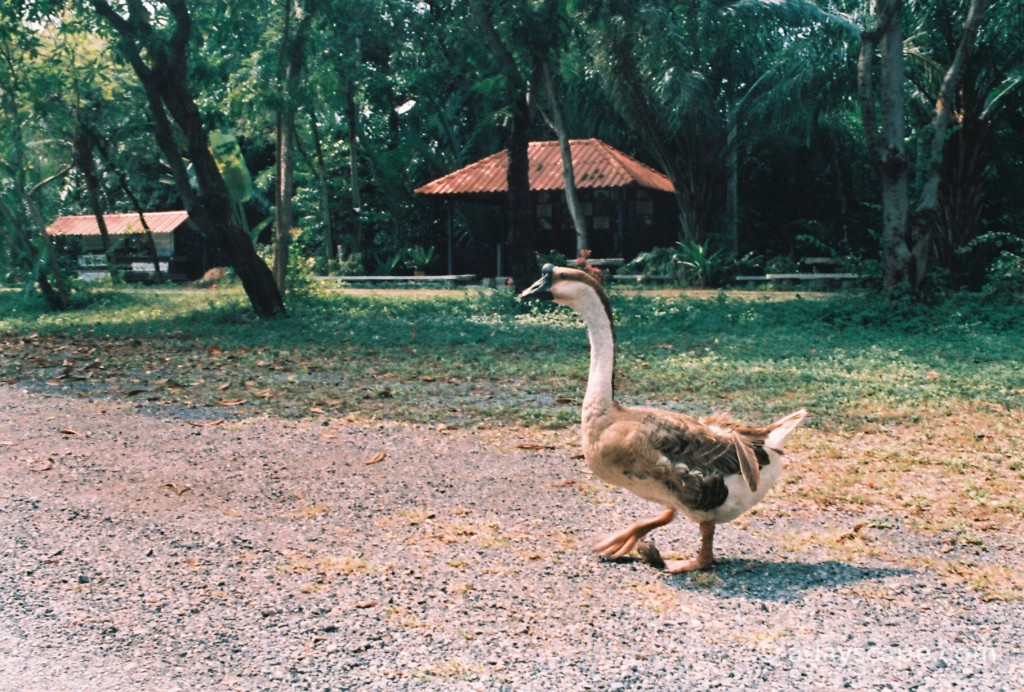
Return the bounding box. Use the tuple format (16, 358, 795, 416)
(414, 139, 678, 270)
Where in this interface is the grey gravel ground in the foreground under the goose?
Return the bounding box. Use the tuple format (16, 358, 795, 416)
(0, 385, 1024, 692)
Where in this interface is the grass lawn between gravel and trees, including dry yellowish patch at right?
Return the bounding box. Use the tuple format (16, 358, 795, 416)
(0, 289, 1024, 599)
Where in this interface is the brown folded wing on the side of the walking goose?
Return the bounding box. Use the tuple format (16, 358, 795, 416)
(636, 409, 769, 510)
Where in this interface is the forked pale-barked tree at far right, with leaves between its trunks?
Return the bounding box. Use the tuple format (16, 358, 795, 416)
(734, 0, 1021, 294)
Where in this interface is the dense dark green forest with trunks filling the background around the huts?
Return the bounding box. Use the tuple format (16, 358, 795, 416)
(0, 0, 1024, 314)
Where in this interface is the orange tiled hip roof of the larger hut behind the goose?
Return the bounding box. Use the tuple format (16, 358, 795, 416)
(414, 139, 675, 194)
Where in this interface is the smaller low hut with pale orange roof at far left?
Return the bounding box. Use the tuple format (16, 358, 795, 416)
(46, 211, 209, 280)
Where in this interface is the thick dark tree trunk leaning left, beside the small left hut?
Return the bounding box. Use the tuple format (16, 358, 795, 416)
(92, 0, 285, 316)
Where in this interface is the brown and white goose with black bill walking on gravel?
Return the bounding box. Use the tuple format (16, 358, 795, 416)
(519, 264, 807, 574)
